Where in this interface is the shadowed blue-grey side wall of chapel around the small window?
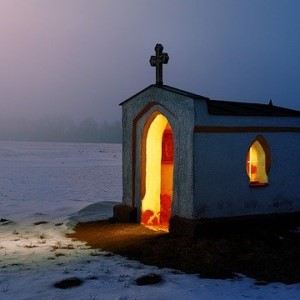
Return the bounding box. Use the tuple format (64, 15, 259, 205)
(194, 101, 300, 219)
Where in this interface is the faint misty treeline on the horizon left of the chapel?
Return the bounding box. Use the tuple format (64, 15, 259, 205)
(0, 117, 122, 143)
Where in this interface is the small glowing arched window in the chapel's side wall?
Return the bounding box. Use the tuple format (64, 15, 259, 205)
(246, 136, 271, 186)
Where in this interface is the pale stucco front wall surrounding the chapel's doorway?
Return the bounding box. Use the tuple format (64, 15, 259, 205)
(122, 86, 194, 218)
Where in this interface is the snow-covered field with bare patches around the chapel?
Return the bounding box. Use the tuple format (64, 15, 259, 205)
(0, 141, 300, 300)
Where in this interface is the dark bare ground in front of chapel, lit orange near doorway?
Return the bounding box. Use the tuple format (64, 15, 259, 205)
(68, 220, 300, 285)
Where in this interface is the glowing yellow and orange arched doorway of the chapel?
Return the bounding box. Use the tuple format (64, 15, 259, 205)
(141, 111, 174, 231)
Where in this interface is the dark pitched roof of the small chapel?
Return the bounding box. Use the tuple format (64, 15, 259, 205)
(120, 84, 300, 117)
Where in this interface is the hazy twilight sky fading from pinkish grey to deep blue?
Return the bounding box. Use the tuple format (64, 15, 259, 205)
(0, 0, 300, 121)
